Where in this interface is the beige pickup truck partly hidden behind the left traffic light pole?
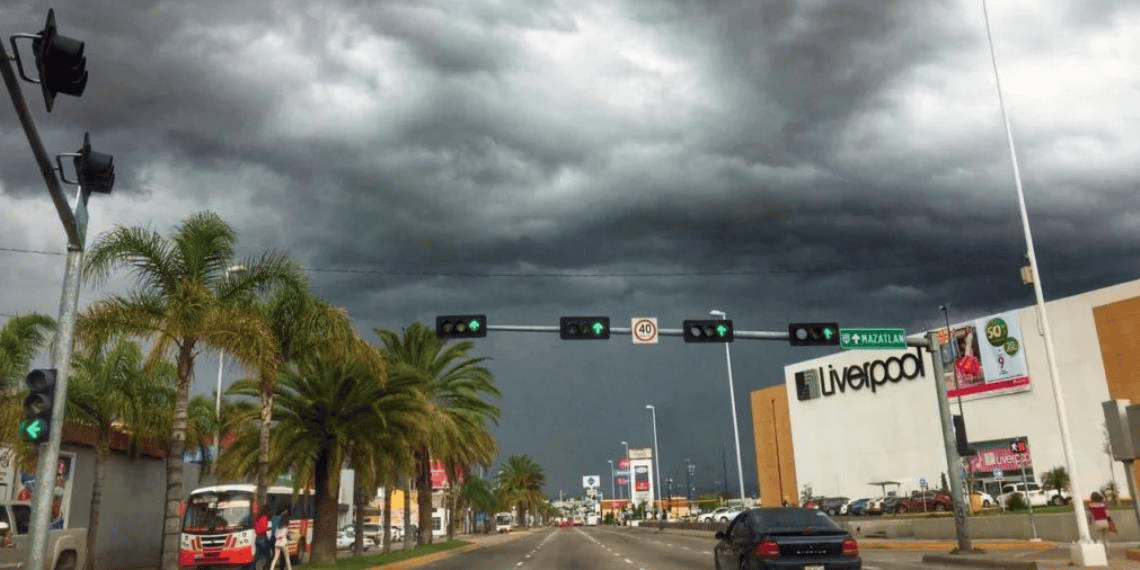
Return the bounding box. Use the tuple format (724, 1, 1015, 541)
(0, 500, 87, 570)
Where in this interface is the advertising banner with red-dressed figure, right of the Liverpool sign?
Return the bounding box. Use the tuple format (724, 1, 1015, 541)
(938, 311, 1032, 399)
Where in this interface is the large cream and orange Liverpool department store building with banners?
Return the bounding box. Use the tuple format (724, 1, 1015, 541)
(751, 280, 1140, 505)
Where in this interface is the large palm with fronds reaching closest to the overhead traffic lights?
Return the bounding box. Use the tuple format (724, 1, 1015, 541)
(376, 323, 502, 544)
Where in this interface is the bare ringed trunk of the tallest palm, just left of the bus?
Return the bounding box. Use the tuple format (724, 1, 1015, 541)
(160, 340, 194, 570)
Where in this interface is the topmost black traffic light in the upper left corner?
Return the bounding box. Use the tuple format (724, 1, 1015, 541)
(13, 10, 87, 113)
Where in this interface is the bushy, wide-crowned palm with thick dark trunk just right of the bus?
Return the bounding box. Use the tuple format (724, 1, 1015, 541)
(218, 344, 424, 562)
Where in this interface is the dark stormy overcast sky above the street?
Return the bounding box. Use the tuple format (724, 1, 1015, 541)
(0, 0, 1140, 496)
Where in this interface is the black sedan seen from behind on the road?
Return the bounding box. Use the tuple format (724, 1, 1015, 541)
(713, 507, 863, 570)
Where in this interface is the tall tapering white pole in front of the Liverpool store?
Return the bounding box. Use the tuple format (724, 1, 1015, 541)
(982, 0, 1108, 565)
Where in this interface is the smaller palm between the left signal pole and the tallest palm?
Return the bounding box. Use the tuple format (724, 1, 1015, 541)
(66, 339, 174, 570)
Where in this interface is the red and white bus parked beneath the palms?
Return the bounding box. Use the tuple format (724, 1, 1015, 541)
(178, 485, 316, 568)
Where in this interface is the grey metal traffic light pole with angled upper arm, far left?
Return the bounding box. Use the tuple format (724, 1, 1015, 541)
(0, 36, 83, 570)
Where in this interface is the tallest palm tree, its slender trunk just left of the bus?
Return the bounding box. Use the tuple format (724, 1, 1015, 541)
(78, 212, 300, 570)
